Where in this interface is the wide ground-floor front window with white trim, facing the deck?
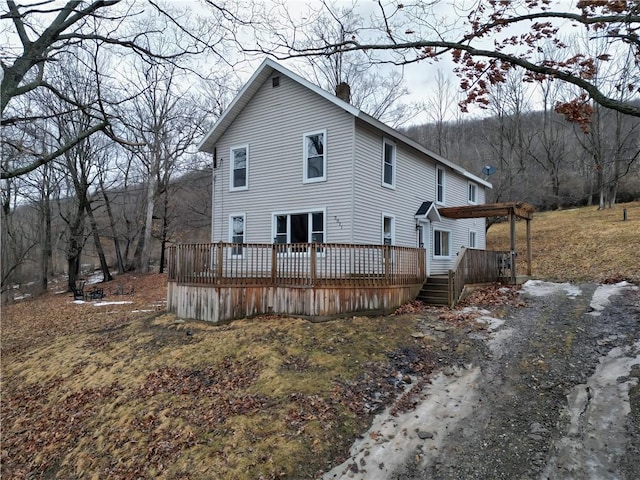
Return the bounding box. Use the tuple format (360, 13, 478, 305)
(273, 211, 325, 251)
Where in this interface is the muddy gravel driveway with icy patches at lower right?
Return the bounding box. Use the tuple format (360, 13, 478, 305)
(322, 281, 640, 480)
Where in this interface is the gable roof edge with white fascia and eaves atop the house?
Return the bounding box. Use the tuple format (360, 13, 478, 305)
(198, 58, 492, 188)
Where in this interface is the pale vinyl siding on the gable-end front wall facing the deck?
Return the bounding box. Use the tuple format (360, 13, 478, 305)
(212, 75, 356, 243)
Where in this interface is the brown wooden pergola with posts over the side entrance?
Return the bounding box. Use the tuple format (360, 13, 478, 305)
(438, 202, 535, 282)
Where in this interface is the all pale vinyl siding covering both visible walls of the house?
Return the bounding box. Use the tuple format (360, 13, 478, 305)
(211, 69, 485, 274)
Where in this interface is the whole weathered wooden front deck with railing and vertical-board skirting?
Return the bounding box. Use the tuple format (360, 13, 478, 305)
(167, 242, 426, 322)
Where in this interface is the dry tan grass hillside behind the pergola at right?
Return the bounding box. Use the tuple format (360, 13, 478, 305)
(487, 202, 640, 283)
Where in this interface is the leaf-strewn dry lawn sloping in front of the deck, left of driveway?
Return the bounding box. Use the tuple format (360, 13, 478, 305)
(2, 277, 440, 479)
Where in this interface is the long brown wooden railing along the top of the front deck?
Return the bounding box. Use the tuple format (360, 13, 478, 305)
(167, 242, 425, 287)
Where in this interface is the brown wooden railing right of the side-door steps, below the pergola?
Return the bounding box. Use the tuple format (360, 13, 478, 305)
(449, 247, 511, 306)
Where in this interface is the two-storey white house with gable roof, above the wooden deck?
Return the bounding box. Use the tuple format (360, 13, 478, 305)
(199, 59, 491, 275)
